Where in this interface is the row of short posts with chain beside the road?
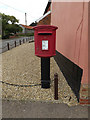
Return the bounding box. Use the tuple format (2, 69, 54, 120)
(0, 36, 34, 53)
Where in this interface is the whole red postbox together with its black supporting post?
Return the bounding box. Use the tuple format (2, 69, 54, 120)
(34, 25, 57, 88)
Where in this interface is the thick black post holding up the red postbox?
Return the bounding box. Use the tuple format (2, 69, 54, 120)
(41, 57, 50, 88)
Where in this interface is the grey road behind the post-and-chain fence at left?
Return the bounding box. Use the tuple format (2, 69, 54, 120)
(0, 36, 33, 53)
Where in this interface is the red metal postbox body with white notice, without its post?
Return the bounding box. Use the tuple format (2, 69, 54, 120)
(34, 25, 58, 57)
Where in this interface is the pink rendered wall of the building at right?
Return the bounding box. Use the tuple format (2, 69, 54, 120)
(51, 2, 88, 84)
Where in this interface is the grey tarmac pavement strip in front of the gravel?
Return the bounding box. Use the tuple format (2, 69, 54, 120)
(2, 100, 88, 118)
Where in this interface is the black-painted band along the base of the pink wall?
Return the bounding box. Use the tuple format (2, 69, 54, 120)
(54, 51, 83, 102)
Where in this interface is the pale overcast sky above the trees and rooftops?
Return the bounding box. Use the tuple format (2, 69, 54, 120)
(0, 0, 48, 25)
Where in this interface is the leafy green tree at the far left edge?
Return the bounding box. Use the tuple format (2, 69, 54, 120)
(0, 13, 22, 38)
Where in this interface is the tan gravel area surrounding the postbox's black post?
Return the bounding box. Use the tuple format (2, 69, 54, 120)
(0, 43, 78, 106)
